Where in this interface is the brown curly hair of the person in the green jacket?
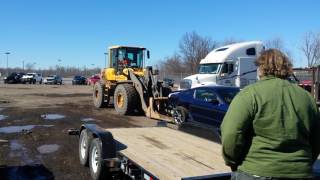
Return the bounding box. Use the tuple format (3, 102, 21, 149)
(255, 49, 292, 79)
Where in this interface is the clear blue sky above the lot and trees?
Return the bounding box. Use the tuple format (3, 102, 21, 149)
(0, 0, 320, 68)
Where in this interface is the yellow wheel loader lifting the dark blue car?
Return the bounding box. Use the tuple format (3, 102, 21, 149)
(93, 46, 171, 121)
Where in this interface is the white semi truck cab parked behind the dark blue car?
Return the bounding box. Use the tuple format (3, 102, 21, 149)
(180, 41, 264, 89)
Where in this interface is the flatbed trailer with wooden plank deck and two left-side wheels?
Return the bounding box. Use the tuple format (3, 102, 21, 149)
(69, 124, 230, 180)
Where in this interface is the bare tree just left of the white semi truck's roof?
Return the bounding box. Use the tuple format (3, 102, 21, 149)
(179, 32, 217, 73)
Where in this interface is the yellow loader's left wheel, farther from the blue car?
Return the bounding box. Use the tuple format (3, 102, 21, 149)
(93, 83, 109, 108)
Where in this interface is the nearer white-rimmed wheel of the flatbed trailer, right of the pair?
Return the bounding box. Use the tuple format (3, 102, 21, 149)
(89, 138, 108, 180)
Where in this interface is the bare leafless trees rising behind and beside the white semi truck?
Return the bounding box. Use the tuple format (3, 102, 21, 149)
(159, 31, 320, 77)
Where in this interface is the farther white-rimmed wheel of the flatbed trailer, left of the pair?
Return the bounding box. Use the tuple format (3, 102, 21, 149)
(79, 129, 92, 166)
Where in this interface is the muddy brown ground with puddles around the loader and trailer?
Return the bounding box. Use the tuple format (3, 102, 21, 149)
(0, 84, 217, 180)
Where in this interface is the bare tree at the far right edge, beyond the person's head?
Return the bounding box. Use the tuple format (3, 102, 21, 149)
(301, 32, 320, 67)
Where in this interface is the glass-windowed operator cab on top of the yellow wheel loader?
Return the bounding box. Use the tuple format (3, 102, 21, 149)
(109, 46, 149, 71)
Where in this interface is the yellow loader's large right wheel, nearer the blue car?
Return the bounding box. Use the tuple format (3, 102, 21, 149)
(113, 84, 139, 115)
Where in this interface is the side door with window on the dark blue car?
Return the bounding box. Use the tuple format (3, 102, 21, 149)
(190, 88, 221, 126)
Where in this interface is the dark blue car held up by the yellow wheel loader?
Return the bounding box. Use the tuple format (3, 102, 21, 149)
(169, 86, 240, 127)
